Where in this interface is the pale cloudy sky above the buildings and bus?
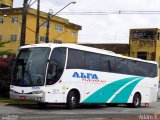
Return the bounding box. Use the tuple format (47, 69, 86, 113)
(14, 0, 160, 44)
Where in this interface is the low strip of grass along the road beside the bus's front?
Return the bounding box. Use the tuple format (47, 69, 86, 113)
(0, 97, 36, 104)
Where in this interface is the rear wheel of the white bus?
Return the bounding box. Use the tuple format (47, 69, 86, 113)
(132, 93, 141, 108)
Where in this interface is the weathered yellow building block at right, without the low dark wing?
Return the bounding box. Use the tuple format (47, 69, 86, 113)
(129, 28, 160, 63)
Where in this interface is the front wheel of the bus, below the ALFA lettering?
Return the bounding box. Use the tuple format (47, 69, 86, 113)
(67, 91, 78, 109)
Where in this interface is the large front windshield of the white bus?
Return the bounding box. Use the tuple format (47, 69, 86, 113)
(11, 47, 50, 87)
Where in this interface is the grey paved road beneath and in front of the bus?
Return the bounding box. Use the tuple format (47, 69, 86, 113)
(0, 102, 160, 120)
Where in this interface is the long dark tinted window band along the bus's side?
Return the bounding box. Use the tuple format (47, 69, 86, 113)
(67, 49, 157, 77)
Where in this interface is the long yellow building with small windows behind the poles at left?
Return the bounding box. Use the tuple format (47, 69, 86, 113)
(0, 8, 82, 52)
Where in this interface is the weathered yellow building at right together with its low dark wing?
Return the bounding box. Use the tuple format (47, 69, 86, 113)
(84, 28, 160, 64)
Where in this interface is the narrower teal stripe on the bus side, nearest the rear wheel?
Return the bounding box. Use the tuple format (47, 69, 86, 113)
(111, 78, 143, 103)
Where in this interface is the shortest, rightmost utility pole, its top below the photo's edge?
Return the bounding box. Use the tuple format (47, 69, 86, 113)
(45, 9, 53, 43)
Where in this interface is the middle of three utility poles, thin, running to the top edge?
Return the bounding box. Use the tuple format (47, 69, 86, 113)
(35, 0, 40, 44)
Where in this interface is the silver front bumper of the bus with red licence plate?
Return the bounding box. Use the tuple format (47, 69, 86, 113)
(10, 91, 45, 102)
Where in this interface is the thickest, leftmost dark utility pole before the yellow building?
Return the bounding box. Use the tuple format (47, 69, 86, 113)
(20, 0, 28, 46)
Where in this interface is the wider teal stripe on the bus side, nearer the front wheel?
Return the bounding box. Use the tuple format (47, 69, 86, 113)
(82, 77, 141, 103)
